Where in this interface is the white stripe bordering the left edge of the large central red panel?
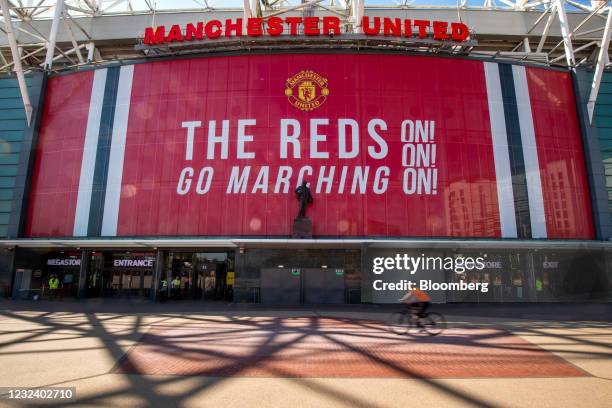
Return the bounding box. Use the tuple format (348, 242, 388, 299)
(102, 65, 134, 237)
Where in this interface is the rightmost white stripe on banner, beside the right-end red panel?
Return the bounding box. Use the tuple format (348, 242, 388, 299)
(512, 65, 547, 238)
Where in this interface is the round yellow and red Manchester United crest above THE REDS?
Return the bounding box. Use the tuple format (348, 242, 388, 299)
(285, 70, 329, 111)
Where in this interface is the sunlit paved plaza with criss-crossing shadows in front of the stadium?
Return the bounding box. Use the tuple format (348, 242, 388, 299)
(0, 302, 612, 408)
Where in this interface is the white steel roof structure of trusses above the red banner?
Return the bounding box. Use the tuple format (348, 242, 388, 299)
(0, 0, 612, 124)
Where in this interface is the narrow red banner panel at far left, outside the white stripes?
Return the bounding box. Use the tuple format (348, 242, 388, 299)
(25, 71, 93, 237)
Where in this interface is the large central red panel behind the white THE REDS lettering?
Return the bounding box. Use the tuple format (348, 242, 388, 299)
(118, 55, 500, 237)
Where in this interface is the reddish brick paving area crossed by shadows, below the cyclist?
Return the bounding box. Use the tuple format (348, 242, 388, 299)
(115, 317, 586, 378)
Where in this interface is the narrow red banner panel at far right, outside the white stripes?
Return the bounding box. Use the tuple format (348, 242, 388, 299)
(527, 68, 595, 239)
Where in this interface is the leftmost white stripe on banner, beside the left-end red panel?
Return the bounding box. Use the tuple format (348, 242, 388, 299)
(72, 68, 107, 237)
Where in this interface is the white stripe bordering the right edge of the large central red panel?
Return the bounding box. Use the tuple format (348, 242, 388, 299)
(484, 62, 517, 238)
